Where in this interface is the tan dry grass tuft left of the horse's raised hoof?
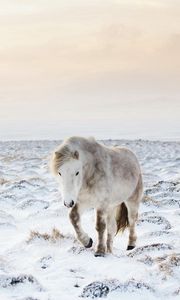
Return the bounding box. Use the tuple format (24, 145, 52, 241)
(27, 228, 65, 243)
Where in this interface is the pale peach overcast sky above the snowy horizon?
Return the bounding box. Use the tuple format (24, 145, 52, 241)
(0, 0, 180, 139)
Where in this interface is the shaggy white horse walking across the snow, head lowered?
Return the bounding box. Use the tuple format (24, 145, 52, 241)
(51, 137, 143, 256)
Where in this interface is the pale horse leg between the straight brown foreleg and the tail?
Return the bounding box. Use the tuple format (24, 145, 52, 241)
(107, 209, 117, 253)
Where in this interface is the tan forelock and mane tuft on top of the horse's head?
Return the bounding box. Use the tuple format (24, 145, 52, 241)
(50, 144, 79, 175)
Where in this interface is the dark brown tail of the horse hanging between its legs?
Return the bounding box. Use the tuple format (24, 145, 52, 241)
(116, 202, 129, 234)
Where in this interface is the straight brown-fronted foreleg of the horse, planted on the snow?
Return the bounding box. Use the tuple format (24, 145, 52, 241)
(95, 210, 106, 256)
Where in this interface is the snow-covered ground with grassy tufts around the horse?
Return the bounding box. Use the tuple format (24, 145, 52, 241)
(0, 140, 180, 300)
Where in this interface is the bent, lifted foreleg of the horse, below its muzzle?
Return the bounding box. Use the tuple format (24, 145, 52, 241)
(69, 204, 93, 248)
